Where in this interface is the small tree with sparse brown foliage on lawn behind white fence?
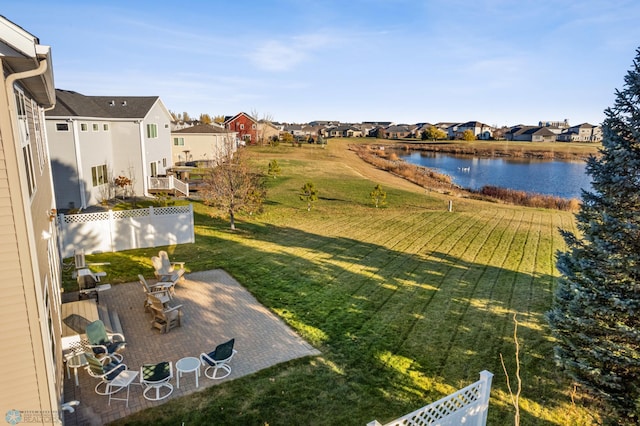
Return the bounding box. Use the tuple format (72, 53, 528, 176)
(201, 140, 266, 230)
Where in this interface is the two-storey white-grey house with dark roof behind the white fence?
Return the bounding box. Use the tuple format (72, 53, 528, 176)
(46, 90, 172, 209)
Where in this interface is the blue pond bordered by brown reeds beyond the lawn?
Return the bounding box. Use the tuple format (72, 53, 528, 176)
(400, 151, 591, 198)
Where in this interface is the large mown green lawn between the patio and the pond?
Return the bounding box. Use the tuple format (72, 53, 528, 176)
(80, 139, 598, 426)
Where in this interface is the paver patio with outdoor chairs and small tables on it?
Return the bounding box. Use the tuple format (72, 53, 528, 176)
(64, 270, 320, 425)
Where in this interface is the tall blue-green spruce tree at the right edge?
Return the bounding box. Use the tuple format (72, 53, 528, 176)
(547, 49, 640, 424)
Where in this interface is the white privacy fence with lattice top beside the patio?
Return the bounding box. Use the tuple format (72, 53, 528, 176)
(58, 204, 195, 259)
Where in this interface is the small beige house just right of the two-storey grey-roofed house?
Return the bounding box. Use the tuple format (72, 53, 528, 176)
(171, 124, 238, 165)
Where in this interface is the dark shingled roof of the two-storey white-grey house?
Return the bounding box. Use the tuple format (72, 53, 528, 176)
(46, 89, 160, 119)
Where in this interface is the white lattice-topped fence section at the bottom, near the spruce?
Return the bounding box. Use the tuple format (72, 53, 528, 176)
(367, 370, 493, 426)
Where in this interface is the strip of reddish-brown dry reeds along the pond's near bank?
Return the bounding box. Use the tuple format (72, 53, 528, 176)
(349, 145, 580, 211)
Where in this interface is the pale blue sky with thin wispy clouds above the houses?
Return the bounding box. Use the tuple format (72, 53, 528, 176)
(5, 0, 640, 126)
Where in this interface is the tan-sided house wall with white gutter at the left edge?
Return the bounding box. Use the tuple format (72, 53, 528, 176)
(0, 16, 64, 425)
